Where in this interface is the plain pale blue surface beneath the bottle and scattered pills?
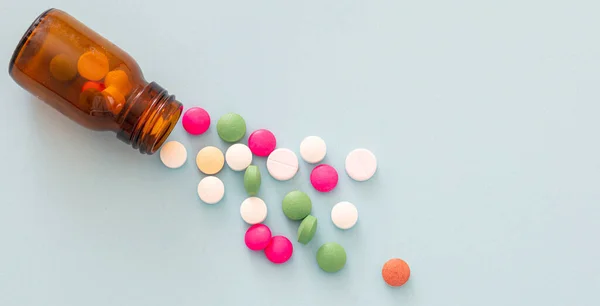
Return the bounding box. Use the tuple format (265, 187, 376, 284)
(0, 0, 600, 306)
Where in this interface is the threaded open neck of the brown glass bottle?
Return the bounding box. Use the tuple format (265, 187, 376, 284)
(117, 82, 183, 154)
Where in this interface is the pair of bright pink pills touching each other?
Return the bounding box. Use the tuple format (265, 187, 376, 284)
(244, 224, 294, 264)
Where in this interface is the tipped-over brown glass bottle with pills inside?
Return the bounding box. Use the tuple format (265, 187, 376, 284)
(8, 9, 183, 154)
